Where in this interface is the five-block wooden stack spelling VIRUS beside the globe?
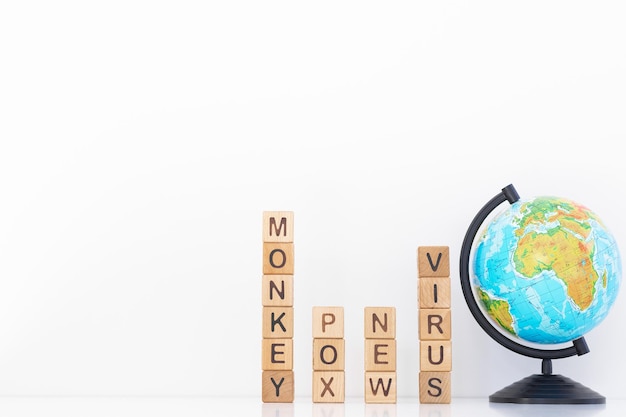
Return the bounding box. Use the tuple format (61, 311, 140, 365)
(417, 246, 452, 404)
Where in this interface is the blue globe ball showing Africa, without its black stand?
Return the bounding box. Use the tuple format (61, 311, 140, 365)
(472, 197, 622, 344)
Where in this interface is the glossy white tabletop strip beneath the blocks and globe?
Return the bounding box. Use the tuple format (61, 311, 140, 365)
(0, 397, 626, 417)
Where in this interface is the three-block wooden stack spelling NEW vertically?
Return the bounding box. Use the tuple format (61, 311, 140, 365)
(364, 307, 397, 403)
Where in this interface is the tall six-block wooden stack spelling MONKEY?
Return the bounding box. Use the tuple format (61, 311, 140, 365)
(261, 211, 294, 403)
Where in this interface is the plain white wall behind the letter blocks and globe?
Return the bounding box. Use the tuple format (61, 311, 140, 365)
(0, 1, 626, 398)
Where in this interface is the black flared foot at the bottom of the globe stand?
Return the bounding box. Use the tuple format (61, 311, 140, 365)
(489, 374, 606, 404)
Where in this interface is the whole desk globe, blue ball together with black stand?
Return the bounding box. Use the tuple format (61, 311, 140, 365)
(459, 184, 622, 404)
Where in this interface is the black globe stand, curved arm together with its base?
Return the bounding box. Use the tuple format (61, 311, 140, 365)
(459, 184, 606, 404)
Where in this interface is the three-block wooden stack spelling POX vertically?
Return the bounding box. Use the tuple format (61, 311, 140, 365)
(312, 307, 346, 403)
